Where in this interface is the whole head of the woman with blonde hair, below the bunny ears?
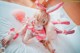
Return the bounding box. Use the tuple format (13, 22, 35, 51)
(34, 10, 50, 25)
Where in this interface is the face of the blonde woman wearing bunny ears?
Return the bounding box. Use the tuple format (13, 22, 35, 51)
(37, 11, 49, 25)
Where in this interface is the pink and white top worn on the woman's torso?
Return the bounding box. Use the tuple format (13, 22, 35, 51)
(27, 22, 46, 40)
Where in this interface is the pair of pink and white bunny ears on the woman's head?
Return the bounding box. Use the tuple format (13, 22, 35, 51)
(35, 0, 64, 14)
